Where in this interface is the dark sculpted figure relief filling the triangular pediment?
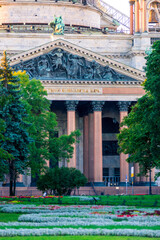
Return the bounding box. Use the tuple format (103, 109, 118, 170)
(13, 48, 136, 82)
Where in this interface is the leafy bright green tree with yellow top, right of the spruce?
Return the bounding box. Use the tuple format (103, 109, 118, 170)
(14, 71, 80, 179)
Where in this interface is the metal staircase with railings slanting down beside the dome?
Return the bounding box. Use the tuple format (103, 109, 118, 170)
(87, 0, 130, 29)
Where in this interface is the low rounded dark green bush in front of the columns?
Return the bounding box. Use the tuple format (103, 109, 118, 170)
(37, 167, 87, 196)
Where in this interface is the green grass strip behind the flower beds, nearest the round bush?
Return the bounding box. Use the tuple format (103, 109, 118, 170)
(0, 195, 160, 207)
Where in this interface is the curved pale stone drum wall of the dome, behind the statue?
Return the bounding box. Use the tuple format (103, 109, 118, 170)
(0, 1, 101, 28)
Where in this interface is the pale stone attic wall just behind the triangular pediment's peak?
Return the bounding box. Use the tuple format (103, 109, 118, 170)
(0, 30, 154, 70)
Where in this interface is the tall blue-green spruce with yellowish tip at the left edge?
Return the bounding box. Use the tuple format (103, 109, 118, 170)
(0, 52, 30, 196)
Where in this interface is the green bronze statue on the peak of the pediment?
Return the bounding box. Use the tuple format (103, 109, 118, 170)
(49, 16, 65, 35)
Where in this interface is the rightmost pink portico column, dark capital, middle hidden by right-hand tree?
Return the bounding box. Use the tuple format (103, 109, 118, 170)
(118, 101, 131, 185)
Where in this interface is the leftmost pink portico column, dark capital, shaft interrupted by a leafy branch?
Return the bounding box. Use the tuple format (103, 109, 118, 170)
(66, 101, 78, 168)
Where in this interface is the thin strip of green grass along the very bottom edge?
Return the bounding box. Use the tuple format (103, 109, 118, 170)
(0, 236, 160, 240)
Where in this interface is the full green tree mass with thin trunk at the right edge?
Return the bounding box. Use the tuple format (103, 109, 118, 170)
(118, 41, 160, 194)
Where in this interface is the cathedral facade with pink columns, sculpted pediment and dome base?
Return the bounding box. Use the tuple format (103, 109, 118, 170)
(0, 0, 160, 186)
